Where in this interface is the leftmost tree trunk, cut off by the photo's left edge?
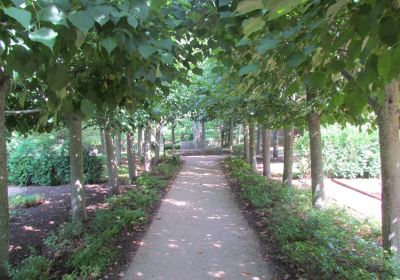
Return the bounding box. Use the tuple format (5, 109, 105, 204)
(0, 73, 10, 280)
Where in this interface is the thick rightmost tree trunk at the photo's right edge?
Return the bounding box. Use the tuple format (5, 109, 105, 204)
(375, 81, 400, 254)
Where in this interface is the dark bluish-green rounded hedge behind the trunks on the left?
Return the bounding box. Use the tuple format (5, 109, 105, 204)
(7, 134, 104, 186)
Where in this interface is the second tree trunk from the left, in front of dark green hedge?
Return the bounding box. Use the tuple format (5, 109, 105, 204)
(68, 113, 87, 222)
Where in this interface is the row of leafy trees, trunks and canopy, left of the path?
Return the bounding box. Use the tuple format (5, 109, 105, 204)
(0, 0, 214, 279)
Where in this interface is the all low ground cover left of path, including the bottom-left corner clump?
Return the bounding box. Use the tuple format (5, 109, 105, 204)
(9, 156, 180, 280)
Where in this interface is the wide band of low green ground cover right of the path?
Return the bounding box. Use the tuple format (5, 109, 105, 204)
(225, 158, 400, 279)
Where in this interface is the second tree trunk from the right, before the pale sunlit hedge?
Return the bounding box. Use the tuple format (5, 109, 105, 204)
(308, 109, 325, 209)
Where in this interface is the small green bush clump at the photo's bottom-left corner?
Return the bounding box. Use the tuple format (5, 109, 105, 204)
(8, 255, 52, 280)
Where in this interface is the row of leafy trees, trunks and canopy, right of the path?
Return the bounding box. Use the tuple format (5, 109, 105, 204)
(195, 0, 400, 255)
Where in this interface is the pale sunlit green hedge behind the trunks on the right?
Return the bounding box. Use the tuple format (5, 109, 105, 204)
(295, 126, 380, 178)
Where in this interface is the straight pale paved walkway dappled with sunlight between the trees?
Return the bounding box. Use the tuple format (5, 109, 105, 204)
(124, 156, 274, 280)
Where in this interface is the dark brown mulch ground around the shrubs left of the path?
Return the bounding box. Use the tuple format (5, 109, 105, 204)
(10, 160, 179, 279)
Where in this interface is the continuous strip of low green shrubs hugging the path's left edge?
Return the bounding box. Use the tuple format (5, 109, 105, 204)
(35, 157, 180, 280)
